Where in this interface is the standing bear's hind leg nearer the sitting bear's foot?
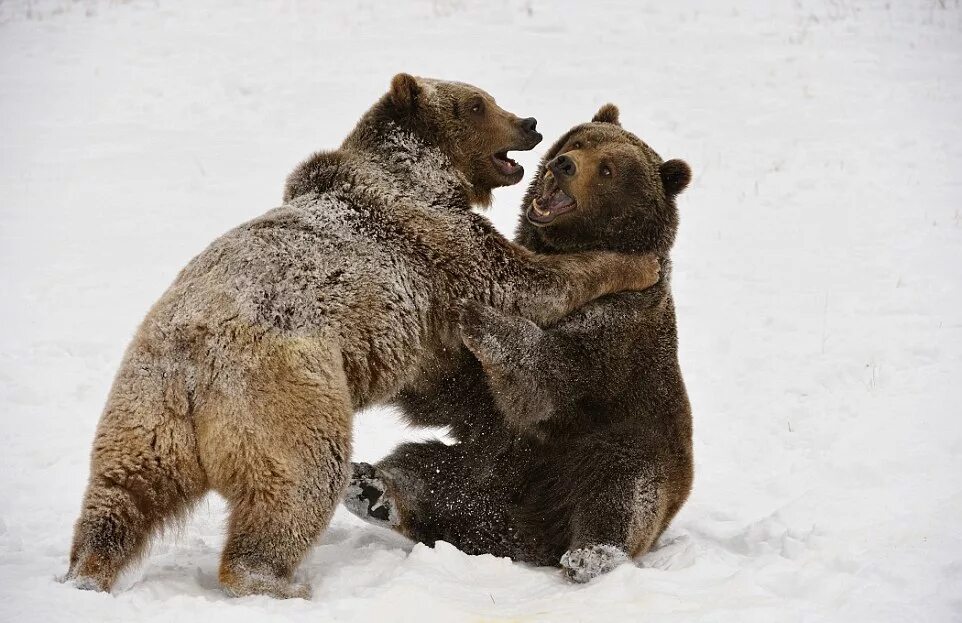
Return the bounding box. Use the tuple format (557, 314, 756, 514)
(198, 340, 352, 598)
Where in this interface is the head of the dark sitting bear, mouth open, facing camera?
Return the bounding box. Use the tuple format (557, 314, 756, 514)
(518, 104, 691, 255)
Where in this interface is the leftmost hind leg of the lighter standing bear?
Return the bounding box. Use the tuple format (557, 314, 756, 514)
(63, 349, 207, 591)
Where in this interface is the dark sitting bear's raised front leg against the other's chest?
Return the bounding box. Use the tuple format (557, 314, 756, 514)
(461, 302, 561, 436)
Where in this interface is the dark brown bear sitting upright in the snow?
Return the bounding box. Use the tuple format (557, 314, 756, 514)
(345, 105, 693, 582)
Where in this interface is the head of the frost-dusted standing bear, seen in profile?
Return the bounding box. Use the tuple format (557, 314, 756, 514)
(366, 73, 541, 205)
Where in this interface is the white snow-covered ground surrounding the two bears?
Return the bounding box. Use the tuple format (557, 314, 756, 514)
(0, 0, 962, 622)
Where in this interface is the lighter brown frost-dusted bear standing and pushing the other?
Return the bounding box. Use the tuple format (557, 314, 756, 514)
(67, 79, 657, 597)
